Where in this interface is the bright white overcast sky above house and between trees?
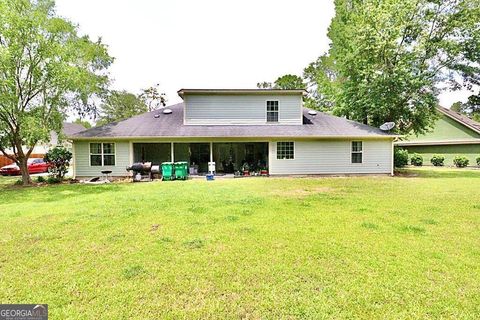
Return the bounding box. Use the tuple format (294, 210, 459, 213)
(56, 0, 467, 107)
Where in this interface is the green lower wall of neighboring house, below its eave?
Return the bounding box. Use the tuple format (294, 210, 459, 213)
(402, 141, 480, 166)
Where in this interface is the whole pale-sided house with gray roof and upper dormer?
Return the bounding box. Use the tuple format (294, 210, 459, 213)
(70, 89, 397, 178)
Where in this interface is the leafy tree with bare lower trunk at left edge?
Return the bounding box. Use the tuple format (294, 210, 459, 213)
(0, 0, 112, 185)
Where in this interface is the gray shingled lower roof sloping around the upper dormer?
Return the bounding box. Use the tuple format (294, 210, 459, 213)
(70, 103, 394, 139)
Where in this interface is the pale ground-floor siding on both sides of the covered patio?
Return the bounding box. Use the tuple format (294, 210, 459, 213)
(74, 139, 392, 177)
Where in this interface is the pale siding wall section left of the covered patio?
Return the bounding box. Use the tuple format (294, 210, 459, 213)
(74, 141, 130, 177)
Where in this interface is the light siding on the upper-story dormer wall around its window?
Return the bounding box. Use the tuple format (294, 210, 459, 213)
(184, 95, 303, 125)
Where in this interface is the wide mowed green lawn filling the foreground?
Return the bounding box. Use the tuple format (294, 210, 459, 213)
(0, 169, 480, 319)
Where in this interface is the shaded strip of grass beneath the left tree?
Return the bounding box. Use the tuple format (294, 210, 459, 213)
(0, 183, 122, 204)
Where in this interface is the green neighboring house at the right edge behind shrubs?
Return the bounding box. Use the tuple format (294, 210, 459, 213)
(396, 107, 480, 166)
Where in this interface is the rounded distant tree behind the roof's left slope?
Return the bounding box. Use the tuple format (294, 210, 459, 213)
(97, 91, 148, 125)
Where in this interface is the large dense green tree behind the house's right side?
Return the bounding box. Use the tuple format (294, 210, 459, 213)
(305, 0, 480, 134)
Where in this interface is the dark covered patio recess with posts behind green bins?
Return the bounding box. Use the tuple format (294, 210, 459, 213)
(132, 142, 268, 175)
